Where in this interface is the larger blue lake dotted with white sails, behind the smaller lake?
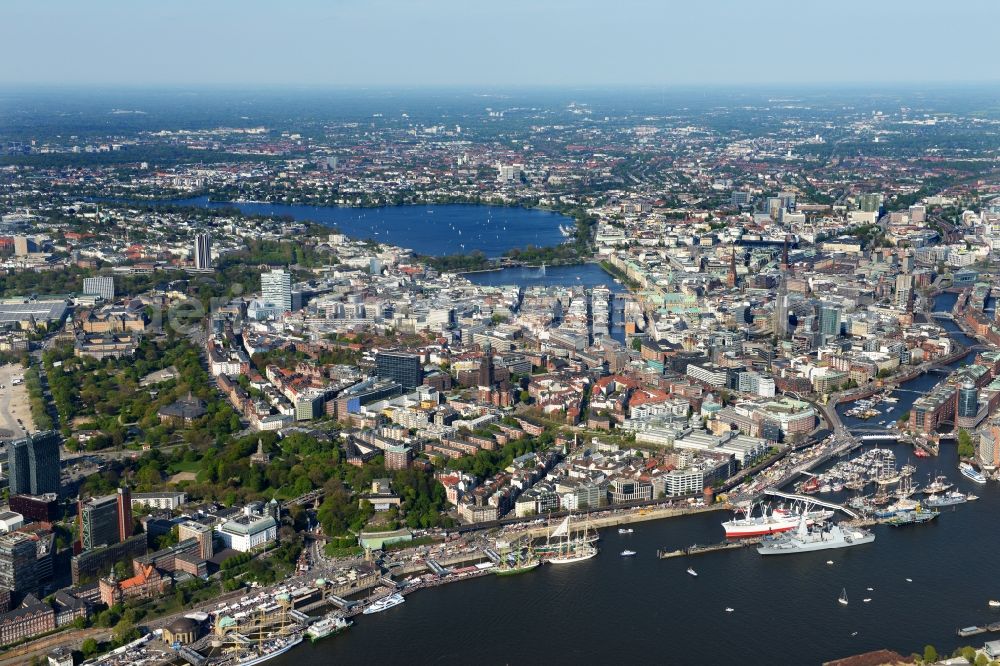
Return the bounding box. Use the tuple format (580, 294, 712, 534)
(166, 197, 576, 258)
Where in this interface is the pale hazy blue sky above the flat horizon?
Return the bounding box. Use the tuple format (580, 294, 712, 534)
(7, 0, 1000, 86)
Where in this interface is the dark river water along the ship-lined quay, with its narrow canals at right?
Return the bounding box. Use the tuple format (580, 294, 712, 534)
(272, 296, 1000, 666)
